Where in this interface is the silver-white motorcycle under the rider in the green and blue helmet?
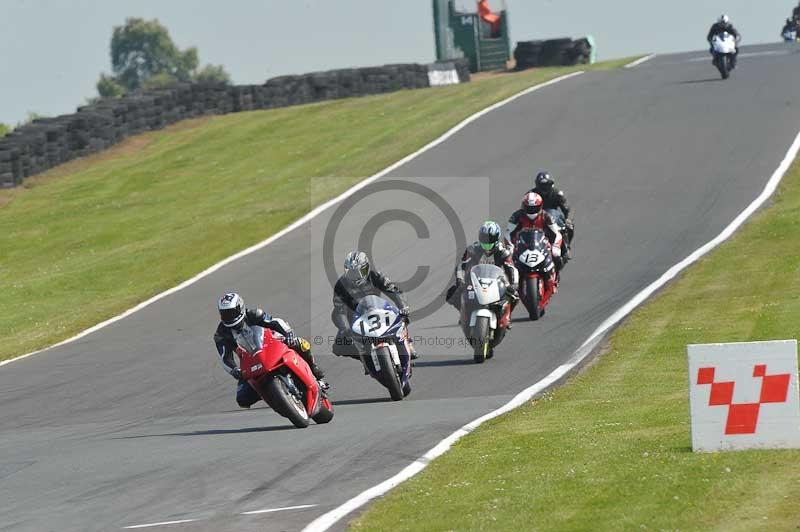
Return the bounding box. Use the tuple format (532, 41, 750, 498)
(461, 264, 511, 364)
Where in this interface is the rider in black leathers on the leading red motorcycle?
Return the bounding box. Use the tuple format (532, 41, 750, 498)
(214, 292, 328, 408)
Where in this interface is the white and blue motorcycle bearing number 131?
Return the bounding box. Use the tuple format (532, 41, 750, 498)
(350, 295, 411, 401)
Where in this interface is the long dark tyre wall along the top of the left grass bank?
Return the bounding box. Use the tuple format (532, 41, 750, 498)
(0, 59, 470, 188)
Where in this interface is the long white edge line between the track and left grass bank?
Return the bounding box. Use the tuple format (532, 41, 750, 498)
(0, 70, 584, 367)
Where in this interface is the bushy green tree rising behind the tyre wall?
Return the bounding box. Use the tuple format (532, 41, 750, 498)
(97, 18, 230, 97)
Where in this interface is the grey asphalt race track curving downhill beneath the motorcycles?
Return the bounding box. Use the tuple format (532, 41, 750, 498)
(0, 45, 800, 532)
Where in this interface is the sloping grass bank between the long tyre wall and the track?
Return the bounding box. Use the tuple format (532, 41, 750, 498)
(0, 60, 629, 359)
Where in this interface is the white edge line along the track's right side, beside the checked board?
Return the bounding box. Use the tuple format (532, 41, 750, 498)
(303, 132, 800, 532)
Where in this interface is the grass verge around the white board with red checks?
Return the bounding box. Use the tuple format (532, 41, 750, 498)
(351, 160, 800, 532)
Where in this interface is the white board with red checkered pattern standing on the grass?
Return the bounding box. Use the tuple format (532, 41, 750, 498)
(687, 340, 800, 451)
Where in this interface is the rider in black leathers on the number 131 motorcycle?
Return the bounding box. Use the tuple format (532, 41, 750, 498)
(331, 251, 417, 359)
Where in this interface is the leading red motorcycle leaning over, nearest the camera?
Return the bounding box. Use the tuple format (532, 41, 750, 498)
(233, 324, 333, 429)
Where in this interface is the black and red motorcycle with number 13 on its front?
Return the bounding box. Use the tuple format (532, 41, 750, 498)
(514, 229, 558, 321)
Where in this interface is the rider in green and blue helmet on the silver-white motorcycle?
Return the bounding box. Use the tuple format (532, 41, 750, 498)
(447, 220, 519, 316)
